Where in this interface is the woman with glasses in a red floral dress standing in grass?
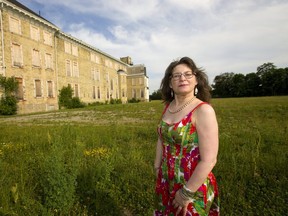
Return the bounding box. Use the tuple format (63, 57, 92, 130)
(154, 57, 219, 216)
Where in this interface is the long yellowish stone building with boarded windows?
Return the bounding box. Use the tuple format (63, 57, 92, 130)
(0, 0, 149, 113)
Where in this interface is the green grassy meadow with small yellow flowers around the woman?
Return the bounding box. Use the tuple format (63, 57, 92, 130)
(0, 96, 288, 216)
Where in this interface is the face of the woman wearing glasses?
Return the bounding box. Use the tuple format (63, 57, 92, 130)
(170, 64, 197, 95)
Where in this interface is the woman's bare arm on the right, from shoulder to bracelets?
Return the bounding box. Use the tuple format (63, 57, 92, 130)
(186, 105, 219, 192)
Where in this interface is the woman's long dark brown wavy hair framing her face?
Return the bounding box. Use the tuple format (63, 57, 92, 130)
(160, 57, 211, 103)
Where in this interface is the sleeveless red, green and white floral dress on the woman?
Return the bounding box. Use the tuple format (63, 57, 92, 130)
(154, 102, 219, 216)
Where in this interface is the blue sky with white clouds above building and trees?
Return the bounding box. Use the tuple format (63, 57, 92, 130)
(18, 0, 288, 94)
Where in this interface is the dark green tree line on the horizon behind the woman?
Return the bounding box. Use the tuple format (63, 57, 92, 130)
(150, 62, 288, 100)
